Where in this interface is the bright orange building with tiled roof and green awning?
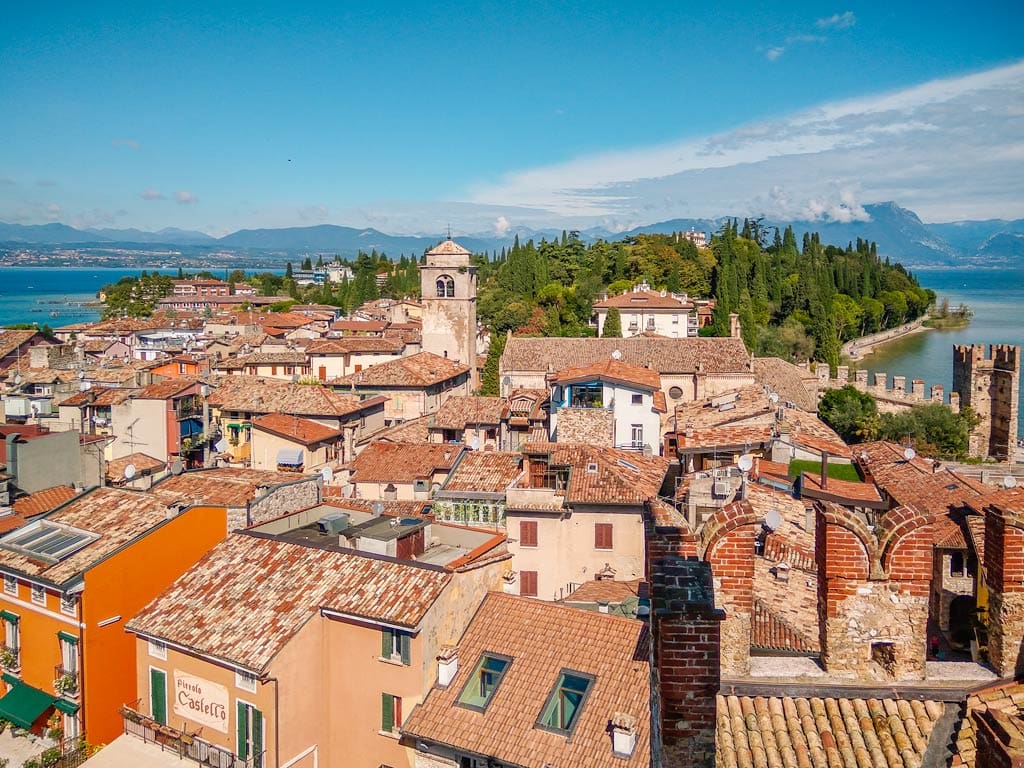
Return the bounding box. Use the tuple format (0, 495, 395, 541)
(0, 488, 226, 743)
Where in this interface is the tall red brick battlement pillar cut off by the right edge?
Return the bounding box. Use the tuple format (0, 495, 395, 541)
(985, 507, 1024, 676)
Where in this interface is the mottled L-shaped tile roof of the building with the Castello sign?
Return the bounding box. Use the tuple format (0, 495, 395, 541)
(127, 534, 451, 672)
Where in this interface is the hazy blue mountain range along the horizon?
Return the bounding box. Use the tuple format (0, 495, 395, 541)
(0, 202, 1024, 267)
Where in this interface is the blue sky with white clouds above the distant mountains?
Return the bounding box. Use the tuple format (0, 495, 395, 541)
(0, 0, 1024, 236)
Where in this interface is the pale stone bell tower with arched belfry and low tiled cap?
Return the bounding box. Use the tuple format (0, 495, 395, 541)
(420, 238, 476, 378)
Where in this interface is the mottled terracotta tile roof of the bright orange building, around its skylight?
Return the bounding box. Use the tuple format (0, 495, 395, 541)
(0, 487, 178, 584)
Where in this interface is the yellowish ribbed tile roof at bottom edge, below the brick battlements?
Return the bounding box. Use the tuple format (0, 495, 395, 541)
(715, 694, 944, 768)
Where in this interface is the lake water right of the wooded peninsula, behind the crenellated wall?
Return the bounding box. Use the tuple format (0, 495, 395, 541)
(858, 268, 1024, 434)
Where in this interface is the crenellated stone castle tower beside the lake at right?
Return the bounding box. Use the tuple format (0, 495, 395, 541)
(953, 344, 1021, 463)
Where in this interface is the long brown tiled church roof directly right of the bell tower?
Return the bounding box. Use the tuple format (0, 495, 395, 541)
(501, 336, 753, 378)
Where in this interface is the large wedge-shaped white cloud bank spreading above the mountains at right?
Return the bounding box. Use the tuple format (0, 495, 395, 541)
(473, 61, 1024, 225)
